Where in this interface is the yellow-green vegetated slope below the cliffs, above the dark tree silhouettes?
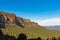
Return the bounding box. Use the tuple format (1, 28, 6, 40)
(1, 24, 60, 39)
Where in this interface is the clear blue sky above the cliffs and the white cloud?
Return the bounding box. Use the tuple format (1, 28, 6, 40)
(0, 0, 60, 20)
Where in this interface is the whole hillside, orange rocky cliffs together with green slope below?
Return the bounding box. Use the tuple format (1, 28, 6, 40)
(0, 12, 60, 39)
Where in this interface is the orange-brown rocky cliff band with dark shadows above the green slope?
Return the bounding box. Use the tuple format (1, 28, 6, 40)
(0, 12, 38, 27)
